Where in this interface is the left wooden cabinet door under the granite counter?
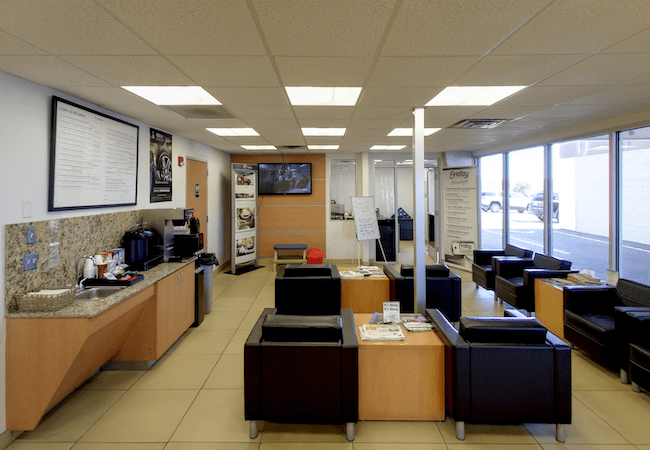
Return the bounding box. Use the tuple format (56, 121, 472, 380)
(156, 272, 180, 359)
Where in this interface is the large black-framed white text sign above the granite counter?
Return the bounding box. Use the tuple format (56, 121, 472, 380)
(48, 97, 140, 211)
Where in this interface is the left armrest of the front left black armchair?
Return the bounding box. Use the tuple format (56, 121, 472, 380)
(244, 308, 276, 420)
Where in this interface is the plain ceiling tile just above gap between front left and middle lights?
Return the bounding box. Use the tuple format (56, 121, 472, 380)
(169, 56, 280, 87)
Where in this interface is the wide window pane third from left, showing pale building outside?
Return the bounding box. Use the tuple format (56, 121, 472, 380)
(548, 135, 609, 280)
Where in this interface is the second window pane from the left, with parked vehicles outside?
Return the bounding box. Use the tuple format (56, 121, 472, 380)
(507, 147, 544, 253)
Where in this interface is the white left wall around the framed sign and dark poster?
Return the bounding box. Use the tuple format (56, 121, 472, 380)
(0, 72, 230, 432)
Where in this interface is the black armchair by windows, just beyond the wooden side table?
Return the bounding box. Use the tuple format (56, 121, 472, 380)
(493, 253, 571, 313)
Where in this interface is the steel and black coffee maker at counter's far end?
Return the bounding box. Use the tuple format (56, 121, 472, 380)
(142, 208, 195, 262)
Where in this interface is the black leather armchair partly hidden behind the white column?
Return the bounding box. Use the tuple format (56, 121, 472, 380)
(384, 264, 461, 322)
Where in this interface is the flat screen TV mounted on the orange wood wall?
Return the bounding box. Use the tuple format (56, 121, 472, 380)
(257, 163, 311, 195)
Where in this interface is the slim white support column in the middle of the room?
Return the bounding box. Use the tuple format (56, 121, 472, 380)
(413, 107, 427, 314)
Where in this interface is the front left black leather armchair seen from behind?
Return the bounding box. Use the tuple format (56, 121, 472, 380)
(244, 308, 359, 441)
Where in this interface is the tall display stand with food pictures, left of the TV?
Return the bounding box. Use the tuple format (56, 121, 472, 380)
(231, 163, 257, 273)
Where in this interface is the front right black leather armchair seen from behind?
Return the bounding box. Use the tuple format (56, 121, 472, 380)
(426, 309, 571, 442)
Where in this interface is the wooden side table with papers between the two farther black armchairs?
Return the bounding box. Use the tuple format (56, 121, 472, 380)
(339, 267, 390, 313)
